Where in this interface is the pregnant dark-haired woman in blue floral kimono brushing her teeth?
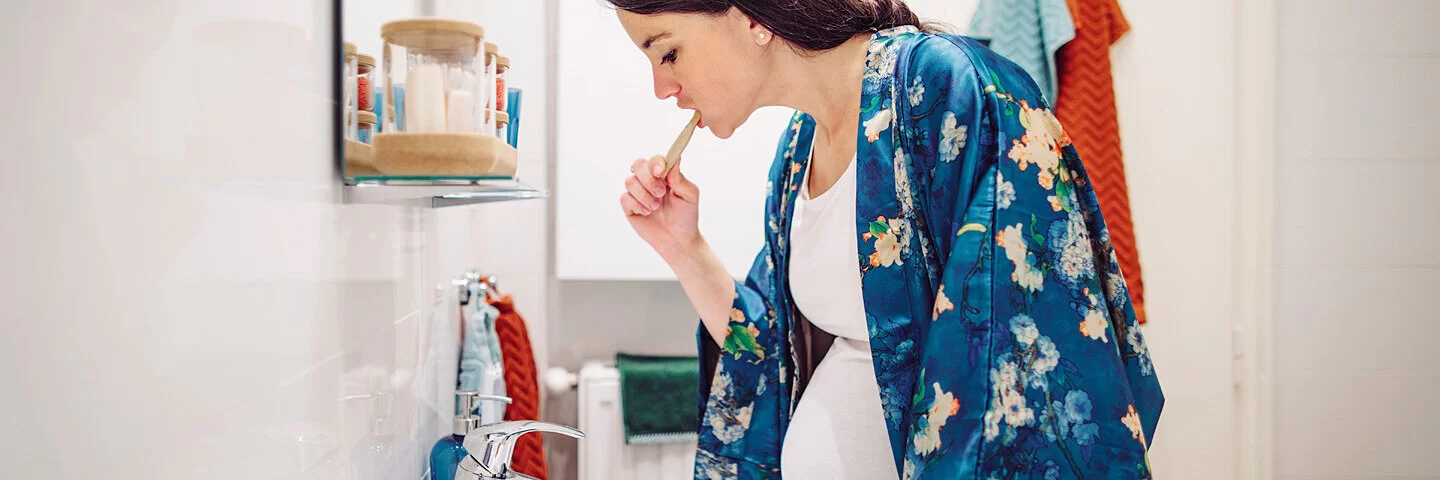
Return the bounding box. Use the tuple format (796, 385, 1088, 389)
(611, 0, 1162, 479)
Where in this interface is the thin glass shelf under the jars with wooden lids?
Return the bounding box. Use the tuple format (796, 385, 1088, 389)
(344, 176, 550, 208)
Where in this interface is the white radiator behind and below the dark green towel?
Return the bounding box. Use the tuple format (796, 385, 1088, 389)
(575, 363, 696, 480)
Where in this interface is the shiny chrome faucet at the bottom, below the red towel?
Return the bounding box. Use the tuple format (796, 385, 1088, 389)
(455, 419, 585, 480)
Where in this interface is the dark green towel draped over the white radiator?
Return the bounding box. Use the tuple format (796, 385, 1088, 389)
(615, 353, 700, 445)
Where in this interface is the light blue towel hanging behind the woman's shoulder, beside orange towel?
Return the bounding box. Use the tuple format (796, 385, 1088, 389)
(966, 0, 1076, 102)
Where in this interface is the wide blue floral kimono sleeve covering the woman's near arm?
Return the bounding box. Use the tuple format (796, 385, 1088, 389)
(900, 36, 1164, 479)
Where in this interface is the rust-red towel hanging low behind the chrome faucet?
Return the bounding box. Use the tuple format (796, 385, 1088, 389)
(490, 295, 547, 480)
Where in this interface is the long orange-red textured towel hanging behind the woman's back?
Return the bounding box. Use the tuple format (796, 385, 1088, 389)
(1056, 0, 1145, 323)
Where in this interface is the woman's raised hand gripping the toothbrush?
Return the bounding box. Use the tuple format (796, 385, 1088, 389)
(621, 156, 701, 259)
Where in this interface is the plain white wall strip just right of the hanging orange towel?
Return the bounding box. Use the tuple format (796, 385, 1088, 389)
(1111, 0, 1238, 479)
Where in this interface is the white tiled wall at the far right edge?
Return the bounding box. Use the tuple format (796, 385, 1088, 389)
(1274, 0, 1440, 480)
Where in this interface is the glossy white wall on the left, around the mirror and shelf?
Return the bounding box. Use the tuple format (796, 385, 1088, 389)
(0, 0, 546, 479)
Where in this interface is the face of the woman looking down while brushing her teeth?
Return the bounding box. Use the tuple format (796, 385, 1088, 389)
(619, 7, 769, 138)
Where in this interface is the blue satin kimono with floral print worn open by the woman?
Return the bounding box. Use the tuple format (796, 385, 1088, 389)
(696, 27, 1164, 479)
